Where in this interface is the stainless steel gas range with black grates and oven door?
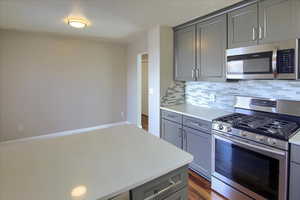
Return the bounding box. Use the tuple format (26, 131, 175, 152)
(212, 96, 300, 200)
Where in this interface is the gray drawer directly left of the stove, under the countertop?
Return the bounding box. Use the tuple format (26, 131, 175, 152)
(183, 116, 211, 133)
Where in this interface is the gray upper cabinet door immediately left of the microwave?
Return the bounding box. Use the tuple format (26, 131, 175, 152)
(197, 15, 227, 80)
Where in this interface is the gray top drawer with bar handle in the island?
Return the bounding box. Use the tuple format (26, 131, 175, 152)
(131, 166, 188, 200)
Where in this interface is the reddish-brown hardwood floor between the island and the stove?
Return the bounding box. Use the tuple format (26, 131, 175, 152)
(188, 170, 228, 200)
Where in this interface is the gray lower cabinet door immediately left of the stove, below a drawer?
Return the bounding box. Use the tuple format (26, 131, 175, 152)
(183, 127, 211, 179)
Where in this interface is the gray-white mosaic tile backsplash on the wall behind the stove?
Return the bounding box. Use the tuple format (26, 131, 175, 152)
(185, 80, 300, 110)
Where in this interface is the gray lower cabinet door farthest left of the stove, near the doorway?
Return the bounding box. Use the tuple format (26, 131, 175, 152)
(162, 119, 182, 149)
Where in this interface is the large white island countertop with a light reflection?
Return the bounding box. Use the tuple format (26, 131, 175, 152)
(0, 125, 193, 200)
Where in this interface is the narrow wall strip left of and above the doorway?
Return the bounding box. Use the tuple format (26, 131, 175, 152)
(127, 34, 148, 126)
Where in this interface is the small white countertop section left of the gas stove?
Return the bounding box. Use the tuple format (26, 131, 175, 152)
(161, 104, 233, 121)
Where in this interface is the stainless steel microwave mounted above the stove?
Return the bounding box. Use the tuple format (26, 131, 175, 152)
(226, 39, 299, 79)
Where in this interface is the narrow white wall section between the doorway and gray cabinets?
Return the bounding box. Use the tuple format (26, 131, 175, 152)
(148, 26, 173, 137)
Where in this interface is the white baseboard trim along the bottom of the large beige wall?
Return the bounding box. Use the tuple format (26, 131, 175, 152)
(0, 121, 131, 144)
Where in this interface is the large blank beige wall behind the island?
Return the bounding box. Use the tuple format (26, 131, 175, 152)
(0, 30, 126, 140)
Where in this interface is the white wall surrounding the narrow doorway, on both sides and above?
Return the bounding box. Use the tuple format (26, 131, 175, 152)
(127, 26, 173, 136)
